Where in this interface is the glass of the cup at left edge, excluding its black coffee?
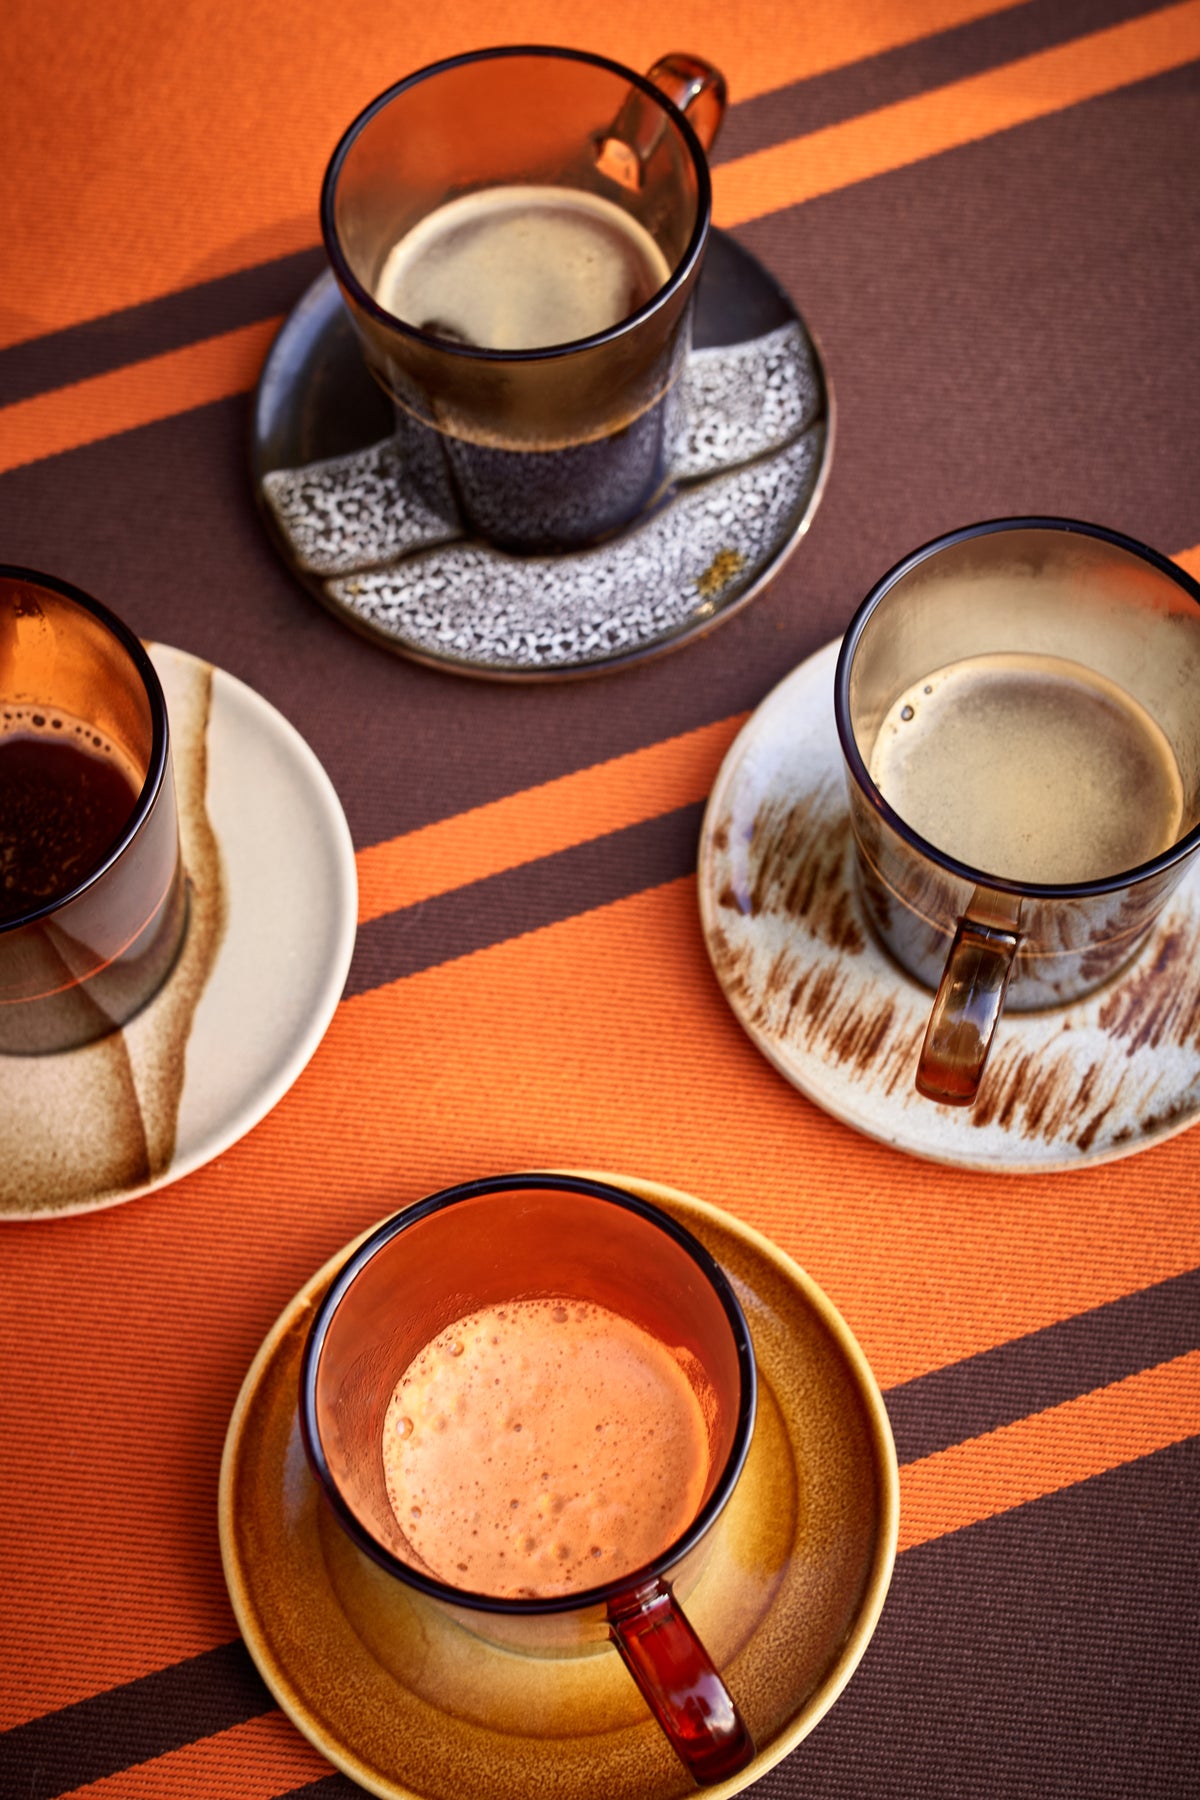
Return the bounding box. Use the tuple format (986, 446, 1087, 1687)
(0, 567, 187, 1055)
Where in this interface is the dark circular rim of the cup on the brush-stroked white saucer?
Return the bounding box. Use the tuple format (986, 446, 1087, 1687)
(833, 513, 1200, 900)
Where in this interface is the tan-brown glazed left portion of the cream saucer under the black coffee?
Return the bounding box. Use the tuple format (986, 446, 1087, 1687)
(0, 657, 225, 1219)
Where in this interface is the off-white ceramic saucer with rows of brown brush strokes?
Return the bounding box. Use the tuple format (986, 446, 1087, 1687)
(698, 643, 1200, 1172)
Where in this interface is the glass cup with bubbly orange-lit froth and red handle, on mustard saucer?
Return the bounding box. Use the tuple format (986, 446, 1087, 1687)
(300, 1174, 756, 1784)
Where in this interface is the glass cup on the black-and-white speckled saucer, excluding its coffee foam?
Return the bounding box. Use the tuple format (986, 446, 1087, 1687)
(320, 47, 725, 551)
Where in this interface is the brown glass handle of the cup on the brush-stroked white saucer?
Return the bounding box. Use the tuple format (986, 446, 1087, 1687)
(916, 918, 1018, 1107)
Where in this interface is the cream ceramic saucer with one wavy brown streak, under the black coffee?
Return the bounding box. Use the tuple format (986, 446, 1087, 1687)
(0, 644, 358, 1219)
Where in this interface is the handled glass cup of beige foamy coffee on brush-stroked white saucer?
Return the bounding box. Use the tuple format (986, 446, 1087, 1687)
(835, 517, 1200, 1105)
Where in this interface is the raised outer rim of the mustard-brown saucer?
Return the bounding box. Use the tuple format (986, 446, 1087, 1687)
(218, 1168, 900, 1800)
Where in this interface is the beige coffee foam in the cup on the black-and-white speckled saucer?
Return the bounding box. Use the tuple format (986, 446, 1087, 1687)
(374, 185, 671, 349)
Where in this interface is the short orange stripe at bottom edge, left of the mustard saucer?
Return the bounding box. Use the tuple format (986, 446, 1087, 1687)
(63, 1712, 325, 1800)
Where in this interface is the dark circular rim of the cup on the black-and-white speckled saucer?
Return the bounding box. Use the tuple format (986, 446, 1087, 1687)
(320, 43, 712, 365)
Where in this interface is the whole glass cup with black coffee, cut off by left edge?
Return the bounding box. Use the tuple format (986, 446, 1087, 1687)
(0, 567, 187, 1055)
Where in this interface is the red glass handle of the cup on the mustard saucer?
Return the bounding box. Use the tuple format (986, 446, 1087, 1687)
(608, 1580, 754, 1787)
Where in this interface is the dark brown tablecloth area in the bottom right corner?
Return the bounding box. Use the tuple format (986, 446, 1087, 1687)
(754, 1438, 1200, 1800)
